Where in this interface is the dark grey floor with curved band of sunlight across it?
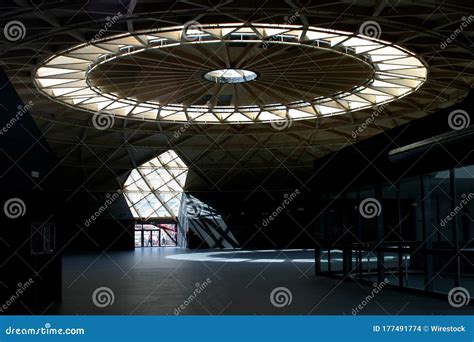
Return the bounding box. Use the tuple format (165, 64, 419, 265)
(54, 247, 472, 315)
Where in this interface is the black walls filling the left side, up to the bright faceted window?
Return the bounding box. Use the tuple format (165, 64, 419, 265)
(0, 68, 134, 314)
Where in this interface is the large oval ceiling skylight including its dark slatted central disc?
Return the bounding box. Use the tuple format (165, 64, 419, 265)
(35, 23, 427, 123)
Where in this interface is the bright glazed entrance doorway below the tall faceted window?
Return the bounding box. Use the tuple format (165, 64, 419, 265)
(135, 223, 177, 248)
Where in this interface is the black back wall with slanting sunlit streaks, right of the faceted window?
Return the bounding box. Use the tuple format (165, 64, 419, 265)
(183, 189, 314, 248)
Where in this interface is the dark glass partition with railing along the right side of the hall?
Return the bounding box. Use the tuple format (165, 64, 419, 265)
(316, 165, 474, 297)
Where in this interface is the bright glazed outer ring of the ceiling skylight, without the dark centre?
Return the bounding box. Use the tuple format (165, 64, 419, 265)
(34, 23, 428, 124)
